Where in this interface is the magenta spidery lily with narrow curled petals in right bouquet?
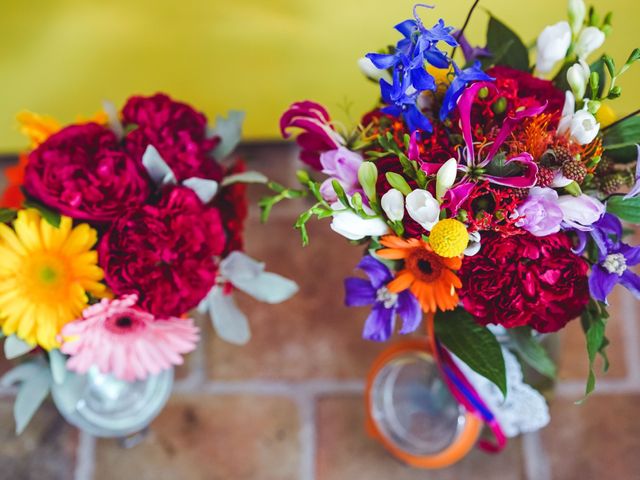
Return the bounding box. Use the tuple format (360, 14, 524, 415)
(421, 82, 547, 215)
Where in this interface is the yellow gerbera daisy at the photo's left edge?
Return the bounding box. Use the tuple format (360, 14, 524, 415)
(0, 209, 106, 350)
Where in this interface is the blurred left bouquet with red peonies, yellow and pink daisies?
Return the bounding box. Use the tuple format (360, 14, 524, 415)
(0, 94, 297, 432)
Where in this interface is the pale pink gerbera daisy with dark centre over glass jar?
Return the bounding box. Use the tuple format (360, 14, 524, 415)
(60, 295, 199, 382)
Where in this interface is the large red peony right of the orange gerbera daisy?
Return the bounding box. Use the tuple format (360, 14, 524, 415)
(458, 233, 589, 332)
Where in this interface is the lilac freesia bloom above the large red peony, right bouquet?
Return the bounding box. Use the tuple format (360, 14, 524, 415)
(515, 187, 563, 237)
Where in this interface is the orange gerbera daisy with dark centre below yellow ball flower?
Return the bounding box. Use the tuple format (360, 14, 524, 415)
(376, 235, 462, 313)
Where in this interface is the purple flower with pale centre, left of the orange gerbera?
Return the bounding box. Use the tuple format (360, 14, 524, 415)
(344, 255, 422, 342)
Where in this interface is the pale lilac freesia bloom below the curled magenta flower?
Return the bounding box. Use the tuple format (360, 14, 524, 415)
(320, 147, 362, 202)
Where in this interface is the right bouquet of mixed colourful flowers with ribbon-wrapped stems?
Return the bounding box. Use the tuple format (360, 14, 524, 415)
(262, 0, 640, 465)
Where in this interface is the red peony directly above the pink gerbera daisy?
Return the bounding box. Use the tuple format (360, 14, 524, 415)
(98, 187, 225, 317)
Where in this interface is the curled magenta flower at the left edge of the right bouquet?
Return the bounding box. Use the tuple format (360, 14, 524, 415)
(280, 101, 347, 170)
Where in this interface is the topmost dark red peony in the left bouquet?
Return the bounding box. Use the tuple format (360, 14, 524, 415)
(122, 93, 223, 181)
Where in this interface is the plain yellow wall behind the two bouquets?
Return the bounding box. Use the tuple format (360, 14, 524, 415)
(0, 0, 640, 152)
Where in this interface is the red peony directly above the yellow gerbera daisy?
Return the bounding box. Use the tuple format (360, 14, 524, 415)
(24, 123, 149, 222)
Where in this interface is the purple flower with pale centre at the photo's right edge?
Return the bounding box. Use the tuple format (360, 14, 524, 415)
(576, 213, 640, 303)
